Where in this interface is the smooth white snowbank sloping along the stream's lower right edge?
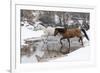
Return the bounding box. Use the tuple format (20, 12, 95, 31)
(49, 46, 90, 62)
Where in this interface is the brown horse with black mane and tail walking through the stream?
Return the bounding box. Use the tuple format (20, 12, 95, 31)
(54, 28, 89, 53)
